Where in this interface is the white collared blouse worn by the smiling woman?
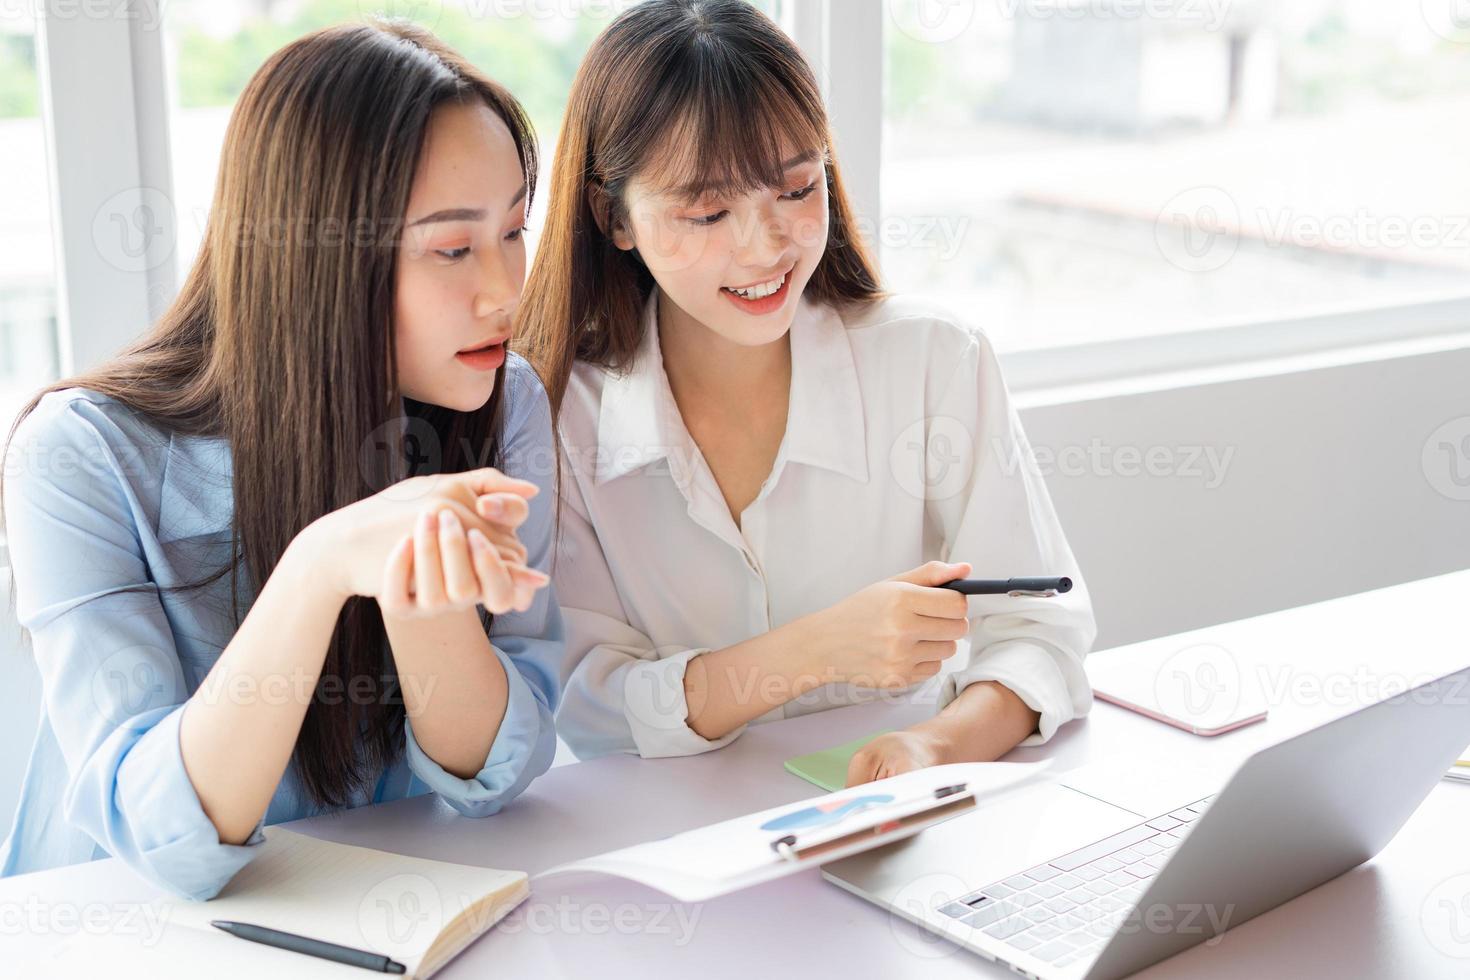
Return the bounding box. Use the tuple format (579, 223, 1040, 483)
(553, 291, 1097, 758)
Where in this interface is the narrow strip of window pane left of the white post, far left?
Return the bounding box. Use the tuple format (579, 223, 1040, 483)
(0, 4, 59, 438)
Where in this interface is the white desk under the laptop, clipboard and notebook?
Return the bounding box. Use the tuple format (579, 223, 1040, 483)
(0, 572, 1470, 980)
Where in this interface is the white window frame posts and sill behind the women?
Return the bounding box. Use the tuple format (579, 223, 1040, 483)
(25, 0, 1470, 402)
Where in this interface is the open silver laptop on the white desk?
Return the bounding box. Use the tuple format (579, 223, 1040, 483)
(822, 667, 1470, 980)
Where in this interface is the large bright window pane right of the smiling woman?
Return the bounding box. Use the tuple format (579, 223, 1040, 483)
(878, 0, 1470, 351)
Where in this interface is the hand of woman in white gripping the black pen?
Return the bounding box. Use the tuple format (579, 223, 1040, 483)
(817, 561, 970, 691)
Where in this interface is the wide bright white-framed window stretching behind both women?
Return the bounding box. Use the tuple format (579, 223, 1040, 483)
(34, 0, 1470, 408)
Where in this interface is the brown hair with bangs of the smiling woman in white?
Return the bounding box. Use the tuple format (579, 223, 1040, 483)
(517, 0, 882, 411)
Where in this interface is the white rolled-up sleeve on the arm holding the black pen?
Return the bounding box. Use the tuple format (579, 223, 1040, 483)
(556, 457, 745, 758)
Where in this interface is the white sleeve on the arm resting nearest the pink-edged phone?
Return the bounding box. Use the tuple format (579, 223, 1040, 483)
(928, 334, 1097, 745)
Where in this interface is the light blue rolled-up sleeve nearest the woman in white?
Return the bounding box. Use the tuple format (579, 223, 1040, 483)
(404, 354, 566, 817)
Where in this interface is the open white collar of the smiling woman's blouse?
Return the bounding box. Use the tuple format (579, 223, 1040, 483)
(595, 288, 867, 485)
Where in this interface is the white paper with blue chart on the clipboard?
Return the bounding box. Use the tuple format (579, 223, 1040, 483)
(537, 761, 1050, 902)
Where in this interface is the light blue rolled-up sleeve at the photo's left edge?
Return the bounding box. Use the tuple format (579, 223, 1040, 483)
(4, 395, 265, 899)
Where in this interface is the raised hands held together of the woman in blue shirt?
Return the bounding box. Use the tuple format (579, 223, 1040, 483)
(303, 467, 548, 616)
